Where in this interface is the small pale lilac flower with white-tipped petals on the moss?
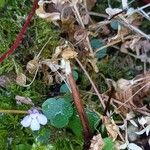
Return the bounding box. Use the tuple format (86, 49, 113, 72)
(21, 109, 47, 131)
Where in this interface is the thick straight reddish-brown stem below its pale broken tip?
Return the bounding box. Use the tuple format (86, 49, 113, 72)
(67, 73, 92, 149)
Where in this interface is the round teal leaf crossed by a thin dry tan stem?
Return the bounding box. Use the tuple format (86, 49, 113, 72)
(91, 39, 107, 58)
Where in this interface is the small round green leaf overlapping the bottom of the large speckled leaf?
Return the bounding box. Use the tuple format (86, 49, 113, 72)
(51, 113, 69, 128)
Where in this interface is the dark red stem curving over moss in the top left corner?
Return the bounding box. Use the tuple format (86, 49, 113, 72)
(0, 0, 38, 63)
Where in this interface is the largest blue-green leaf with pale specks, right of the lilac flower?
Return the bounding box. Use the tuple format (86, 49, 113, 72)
(42, 98, 73, 120)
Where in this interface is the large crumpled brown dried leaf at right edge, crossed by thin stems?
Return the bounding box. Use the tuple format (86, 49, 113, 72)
(114, 72, 150, 116)
